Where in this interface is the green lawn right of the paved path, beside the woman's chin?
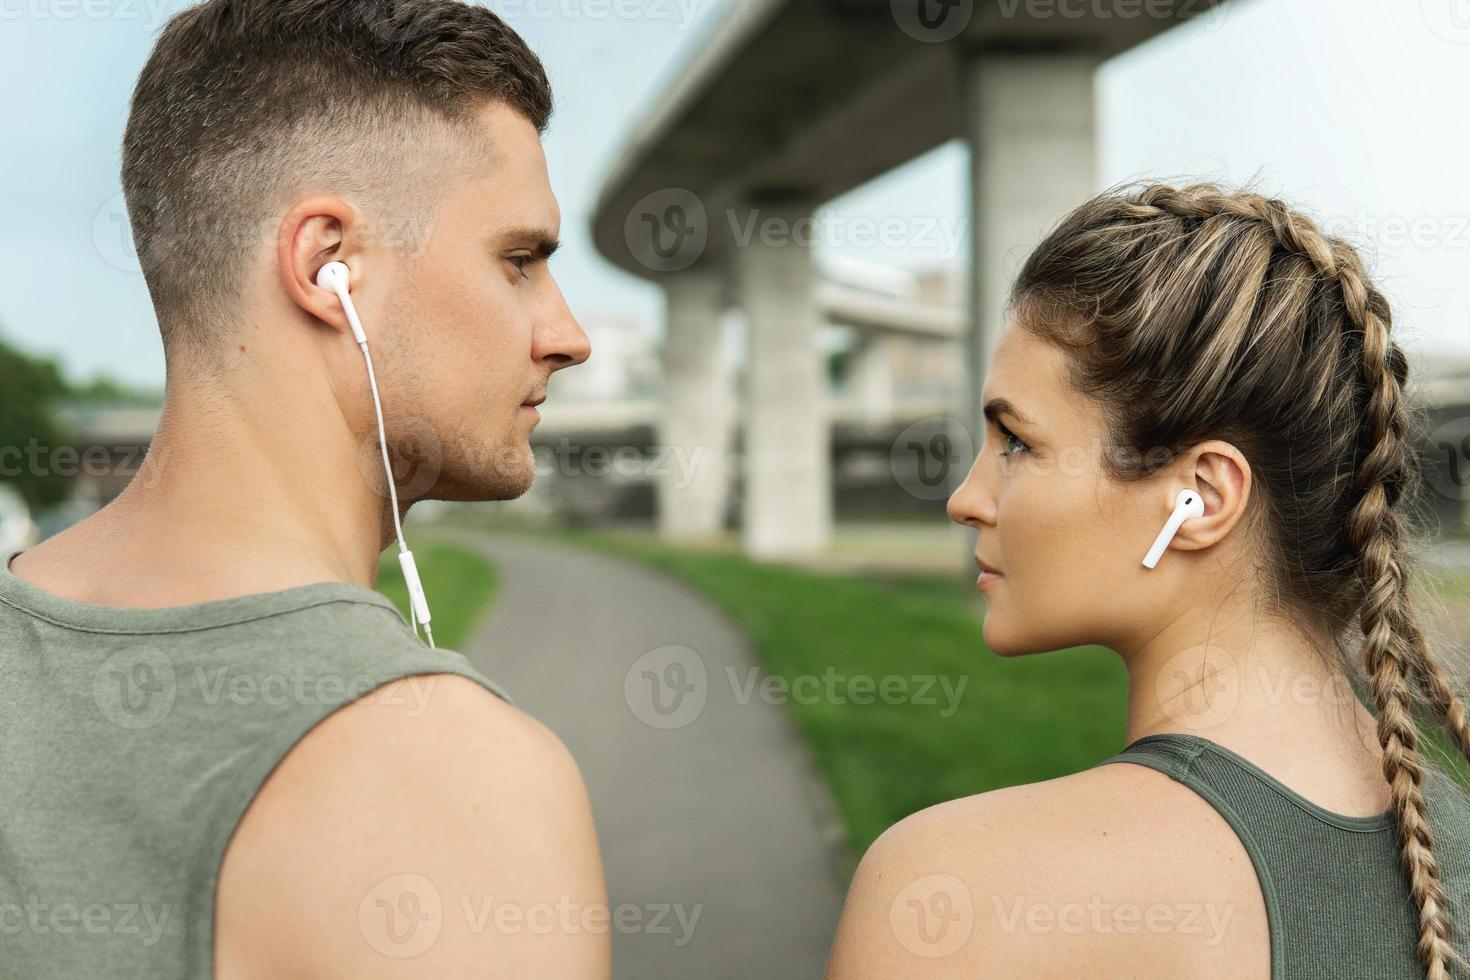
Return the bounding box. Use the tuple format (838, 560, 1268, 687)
(458, 532, 1127, 855)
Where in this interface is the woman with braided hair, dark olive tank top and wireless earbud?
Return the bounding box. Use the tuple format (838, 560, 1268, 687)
(828, 185, 1470, 980)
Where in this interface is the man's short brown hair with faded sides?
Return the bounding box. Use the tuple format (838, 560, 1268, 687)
(122, 0, 551, 361)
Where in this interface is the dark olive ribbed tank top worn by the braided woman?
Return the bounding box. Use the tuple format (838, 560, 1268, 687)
(1100, 735, 1470, 980)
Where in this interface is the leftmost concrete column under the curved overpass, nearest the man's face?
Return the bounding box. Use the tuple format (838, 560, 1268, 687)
(657, 267, 735, 541)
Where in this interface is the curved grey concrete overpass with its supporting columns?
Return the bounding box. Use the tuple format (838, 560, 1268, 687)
(592, 0, 1225, 557)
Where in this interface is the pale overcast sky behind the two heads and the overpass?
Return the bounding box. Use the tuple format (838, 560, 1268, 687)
(0, 0, 1470, 385)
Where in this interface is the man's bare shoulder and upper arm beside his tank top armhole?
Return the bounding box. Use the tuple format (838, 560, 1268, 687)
(216, 674, 606, 977)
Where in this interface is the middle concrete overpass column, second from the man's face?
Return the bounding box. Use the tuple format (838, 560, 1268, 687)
(735, 203, 832, 558)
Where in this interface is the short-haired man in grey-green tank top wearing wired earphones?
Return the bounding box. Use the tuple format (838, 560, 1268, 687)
(0, 0, 609, 980)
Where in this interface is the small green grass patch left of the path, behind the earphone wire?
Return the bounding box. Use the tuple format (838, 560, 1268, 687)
(378, 542, 500, 649)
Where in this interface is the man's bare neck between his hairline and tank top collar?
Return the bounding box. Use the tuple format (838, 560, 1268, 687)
(12, 388, 392, 608)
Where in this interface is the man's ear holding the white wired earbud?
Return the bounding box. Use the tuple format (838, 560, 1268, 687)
(276, 195, 368, 335)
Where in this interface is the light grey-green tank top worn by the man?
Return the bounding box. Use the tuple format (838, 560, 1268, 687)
(0, 551, 509, 980)
